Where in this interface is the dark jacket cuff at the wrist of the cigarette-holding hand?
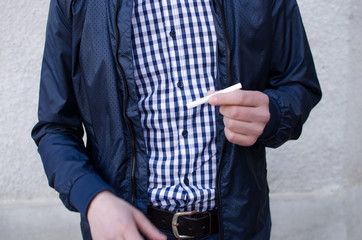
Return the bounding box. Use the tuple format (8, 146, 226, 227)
(259, 96, 280, 143)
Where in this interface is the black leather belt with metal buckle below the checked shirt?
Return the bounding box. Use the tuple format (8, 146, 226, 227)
(147, 207, 218, 239)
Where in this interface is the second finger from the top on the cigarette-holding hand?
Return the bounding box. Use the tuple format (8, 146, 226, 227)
(219, 105, 270, 123)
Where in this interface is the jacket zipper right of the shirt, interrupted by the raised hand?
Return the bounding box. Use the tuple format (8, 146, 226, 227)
(214, 0, 231, 239)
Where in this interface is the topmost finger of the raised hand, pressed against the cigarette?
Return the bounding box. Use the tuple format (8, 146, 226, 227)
(209, 90, 269, 107)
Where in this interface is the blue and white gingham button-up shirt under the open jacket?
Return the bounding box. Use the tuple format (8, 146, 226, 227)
(132, 0, 218, 211)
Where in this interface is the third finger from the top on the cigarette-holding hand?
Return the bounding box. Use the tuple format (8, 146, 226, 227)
(224, 117, 265, 136)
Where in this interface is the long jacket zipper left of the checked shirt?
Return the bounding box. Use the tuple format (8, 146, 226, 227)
(114, 0, 136, 204)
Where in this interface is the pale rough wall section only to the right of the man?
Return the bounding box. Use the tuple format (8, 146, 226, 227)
(268, 0, 362, 240)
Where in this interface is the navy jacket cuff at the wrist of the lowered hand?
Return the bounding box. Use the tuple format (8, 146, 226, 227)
(70, 173, 114, 218)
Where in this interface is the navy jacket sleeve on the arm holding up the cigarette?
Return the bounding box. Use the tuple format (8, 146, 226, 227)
(259, 0, 322, 147)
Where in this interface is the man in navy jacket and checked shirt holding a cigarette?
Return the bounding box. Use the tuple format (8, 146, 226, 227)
(32, 0, 321, 240)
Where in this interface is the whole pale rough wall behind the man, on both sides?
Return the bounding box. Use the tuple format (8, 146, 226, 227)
(0, 0, 362, 240)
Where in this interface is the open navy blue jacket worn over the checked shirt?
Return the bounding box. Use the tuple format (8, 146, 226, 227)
(32, 0, 321, 239)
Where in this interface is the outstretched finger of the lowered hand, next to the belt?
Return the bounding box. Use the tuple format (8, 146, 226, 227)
(133, 210, 167, 240)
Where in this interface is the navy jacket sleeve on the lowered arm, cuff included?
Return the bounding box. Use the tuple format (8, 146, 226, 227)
(32, 0, 112, 216)
